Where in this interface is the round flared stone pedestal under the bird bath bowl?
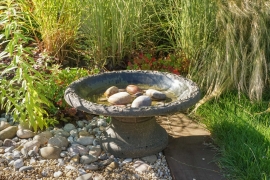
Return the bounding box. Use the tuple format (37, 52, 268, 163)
(101, 117, 168, 158)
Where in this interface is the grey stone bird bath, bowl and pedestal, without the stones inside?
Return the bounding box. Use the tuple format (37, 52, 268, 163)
(64, 70, 200, 158)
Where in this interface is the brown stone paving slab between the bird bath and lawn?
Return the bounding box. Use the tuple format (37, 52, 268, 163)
(157, 113, 225, 180)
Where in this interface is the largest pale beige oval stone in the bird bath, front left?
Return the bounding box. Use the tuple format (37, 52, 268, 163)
(108, 92, 132, 105)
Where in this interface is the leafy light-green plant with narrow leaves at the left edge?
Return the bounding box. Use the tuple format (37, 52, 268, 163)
(0, 0, 55, 131)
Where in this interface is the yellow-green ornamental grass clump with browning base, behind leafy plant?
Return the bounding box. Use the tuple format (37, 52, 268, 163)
(30, 0, 81, 63)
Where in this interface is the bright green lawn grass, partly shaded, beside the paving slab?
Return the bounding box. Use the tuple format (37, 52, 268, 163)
(197, 93, 270, 180)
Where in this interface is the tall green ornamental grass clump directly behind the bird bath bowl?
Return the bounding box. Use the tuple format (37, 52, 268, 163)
(81, 0, 160, 67)
